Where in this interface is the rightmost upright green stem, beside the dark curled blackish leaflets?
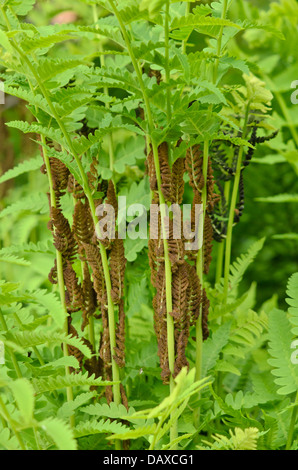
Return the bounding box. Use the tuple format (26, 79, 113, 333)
(224, 103, 250, 303)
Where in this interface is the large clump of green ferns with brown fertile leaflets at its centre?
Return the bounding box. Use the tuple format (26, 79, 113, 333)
(0, 0, 298, 450)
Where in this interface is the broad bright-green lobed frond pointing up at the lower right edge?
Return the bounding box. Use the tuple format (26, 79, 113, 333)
(268, 309, 298, 395)
